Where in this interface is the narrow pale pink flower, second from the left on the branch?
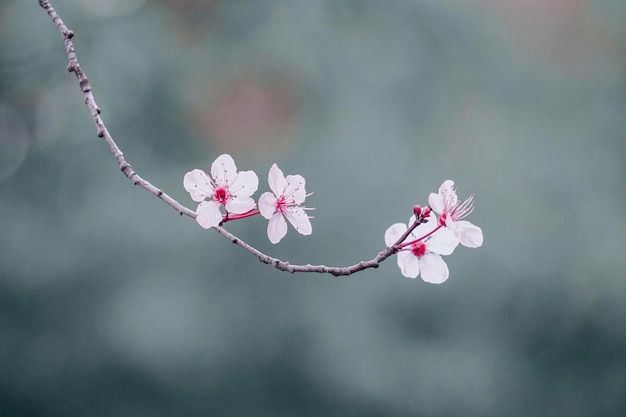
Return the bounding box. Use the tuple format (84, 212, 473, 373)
(259, 164, 312, 243)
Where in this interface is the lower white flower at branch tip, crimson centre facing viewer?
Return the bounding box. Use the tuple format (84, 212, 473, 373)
(385, 215, 459, 284)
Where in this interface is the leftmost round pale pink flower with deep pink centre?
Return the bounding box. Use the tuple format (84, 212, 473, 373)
(183, 154, 259, 229)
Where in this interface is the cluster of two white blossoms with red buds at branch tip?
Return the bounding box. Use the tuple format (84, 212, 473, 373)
(385, 180, 483, 284)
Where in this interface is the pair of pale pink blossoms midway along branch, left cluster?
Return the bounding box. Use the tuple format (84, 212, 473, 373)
(183, 154, 312, 243)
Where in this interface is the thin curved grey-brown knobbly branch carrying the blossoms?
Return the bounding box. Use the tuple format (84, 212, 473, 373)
(39, 0, 400, 276)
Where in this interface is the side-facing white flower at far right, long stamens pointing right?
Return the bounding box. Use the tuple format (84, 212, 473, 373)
(428, 180, 483, 248)
